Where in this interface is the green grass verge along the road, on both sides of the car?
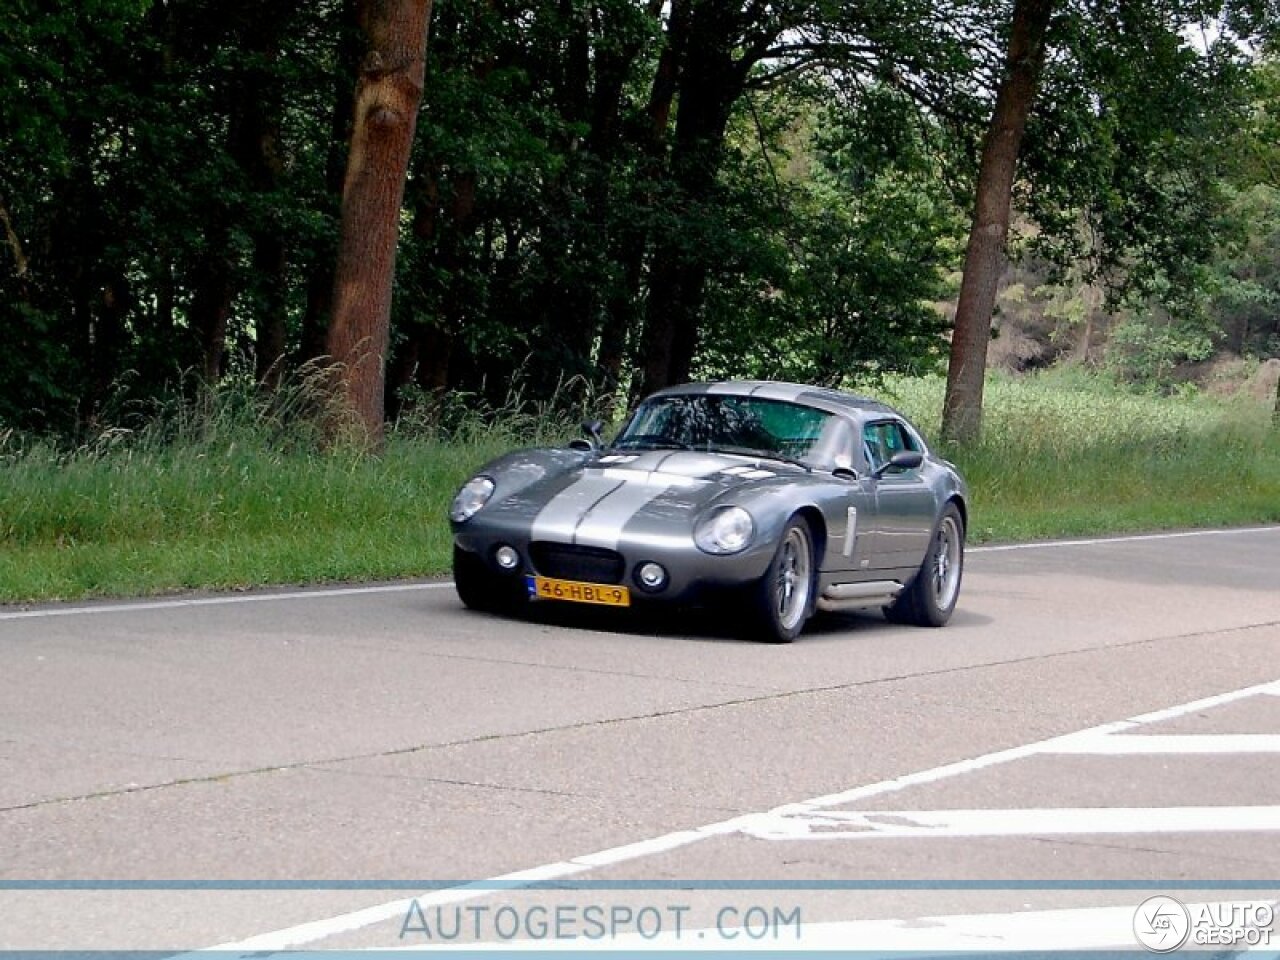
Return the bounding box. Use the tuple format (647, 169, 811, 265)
(0, 374, 1280, 602)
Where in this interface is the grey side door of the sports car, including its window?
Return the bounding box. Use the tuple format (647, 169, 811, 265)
(863, 417, 934, 570)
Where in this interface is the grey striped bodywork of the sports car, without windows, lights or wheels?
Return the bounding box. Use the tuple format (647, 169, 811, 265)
(453, 381, 968, 609)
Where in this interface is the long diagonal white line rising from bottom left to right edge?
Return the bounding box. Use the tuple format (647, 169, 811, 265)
(186, 680, 1280, 960)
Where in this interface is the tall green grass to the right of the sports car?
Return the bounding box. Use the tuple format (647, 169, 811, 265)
(886, 369, 1280, 540)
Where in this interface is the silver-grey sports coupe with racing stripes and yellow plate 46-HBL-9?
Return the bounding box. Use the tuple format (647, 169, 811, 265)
(449, 381, 968, 643)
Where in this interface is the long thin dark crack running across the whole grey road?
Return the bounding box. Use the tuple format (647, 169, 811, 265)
(0, 620, 1280, 814)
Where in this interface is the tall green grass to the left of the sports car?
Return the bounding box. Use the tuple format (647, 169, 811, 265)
(0, 383, 586, 602)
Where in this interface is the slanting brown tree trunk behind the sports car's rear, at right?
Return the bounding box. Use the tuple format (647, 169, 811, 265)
(942, 0, 1055, 442)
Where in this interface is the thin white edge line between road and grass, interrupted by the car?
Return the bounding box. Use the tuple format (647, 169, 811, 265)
(0, 526, 1280, 624)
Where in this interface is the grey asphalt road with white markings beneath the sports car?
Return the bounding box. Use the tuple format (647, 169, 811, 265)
(0, 527, 1280, 951)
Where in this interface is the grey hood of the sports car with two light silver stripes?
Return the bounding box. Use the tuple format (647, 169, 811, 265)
(485, 451, 806, 548)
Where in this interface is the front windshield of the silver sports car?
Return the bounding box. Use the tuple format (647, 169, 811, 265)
(613, 393, 837, 466)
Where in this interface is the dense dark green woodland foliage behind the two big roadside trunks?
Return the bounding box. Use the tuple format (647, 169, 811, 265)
(0, 0, 1280, 434)
